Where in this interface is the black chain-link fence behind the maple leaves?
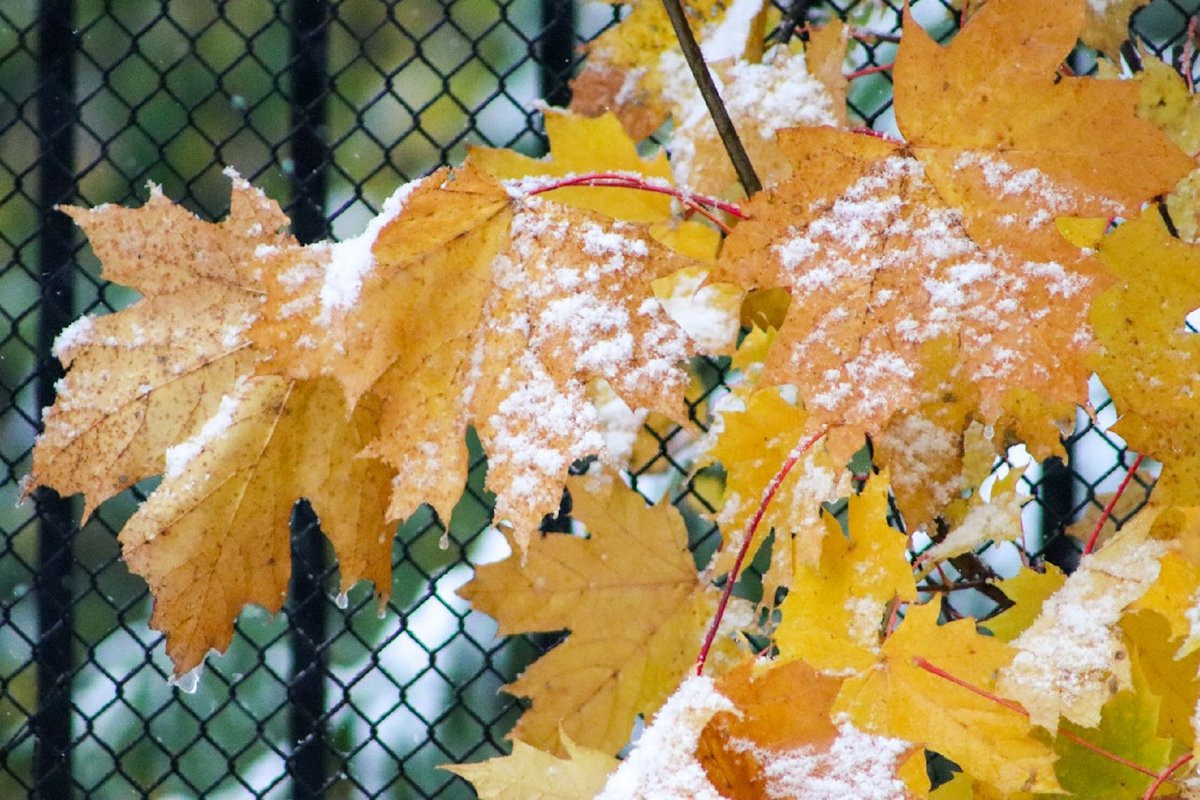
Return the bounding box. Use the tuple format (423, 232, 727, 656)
(0, 0, 1195, 799)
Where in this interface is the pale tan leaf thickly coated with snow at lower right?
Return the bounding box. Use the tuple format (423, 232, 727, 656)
(996, 517, 1165, 730)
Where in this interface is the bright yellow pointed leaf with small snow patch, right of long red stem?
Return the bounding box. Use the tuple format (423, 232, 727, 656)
(775, 475, 917, 676)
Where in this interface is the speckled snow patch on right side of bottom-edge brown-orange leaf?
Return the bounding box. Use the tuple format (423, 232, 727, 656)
(757, 718, 912, 800)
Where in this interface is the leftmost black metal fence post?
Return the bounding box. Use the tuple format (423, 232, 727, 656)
(30, 0, 78, 800)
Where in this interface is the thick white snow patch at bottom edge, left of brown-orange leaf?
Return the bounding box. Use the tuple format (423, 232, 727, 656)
(596, 675, 734, 800)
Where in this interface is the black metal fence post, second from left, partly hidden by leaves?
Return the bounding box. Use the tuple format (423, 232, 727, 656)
(288, 0, 330, 800)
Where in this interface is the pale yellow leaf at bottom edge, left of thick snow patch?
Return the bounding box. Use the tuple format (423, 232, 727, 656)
(442, 736, 619, 800)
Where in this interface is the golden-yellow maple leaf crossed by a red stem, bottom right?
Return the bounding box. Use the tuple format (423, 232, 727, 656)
(834, 603, 1058, 796)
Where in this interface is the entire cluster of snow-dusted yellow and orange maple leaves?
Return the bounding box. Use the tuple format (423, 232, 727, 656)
(31, 0, 1200, 800)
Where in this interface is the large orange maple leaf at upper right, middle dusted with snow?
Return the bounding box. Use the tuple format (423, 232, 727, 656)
(714, 0, 1190, 525)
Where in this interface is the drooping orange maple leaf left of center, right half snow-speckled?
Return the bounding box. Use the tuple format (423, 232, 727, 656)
(250, 167, 691, 547)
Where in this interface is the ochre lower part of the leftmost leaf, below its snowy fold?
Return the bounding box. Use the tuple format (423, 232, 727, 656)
(120, 377, 392, 673)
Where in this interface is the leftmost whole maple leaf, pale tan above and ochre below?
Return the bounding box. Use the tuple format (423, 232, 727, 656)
(32, 176, 394, 674)
